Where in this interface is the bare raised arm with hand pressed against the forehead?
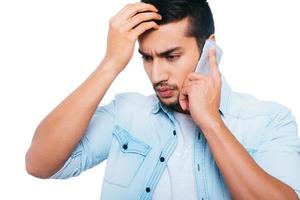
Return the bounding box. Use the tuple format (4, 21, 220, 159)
(26, 3, 160, 178)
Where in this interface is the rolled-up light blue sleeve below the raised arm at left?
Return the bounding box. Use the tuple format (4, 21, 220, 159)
(50, 100, 115, 179)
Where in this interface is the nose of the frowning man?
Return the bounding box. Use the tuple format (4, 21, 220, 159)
(151, 59, 169, 83)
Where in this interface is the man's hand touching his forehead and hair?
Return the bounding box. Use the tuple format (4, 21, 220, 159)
(104, 2, 161, 73)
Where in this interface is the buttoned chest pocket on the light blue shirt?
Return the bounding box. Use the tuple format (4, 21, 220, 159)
(104, 126, 151, 187)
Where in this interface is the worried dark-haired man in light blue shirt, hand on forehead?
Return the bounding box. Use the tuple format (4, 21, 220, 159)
(26, 0, 300, 200)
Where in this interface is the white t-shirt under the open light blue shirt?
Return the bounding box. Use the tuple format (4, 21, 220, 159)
(152, 112, 197, 200)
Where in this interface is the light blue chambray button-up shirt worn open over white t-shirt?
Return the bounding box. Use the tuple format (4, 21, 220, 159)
(50, 74, 300, 200)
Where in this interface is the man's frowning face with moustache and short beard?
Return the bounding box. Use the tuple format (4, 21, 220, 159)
(139, 18, 200, 112)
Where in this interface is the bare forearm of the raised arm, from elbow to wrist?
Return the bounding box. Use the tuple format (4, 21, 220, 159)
(26, 61, 117, 178)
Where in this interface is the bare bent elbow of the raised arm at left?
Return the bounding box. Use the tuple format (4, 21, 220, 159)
(25, 149, 51, 179)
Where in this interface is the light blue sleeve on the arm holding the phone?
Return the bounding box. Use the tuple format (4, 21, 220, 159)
(254, 107, 300, 197)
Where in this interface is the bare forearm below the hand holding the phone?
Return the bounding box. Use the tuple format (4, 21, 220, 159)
(197, 115, 298, 200)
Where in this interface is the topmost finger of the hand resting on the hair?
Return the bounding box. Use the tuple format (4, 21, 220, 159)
(122, 2, 158, 20)
